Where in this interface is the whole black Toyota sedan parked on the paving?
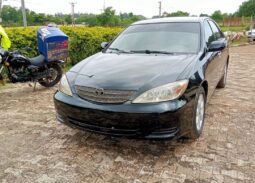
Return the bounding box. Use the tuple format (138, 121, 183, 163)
(54, 17, 229, 139)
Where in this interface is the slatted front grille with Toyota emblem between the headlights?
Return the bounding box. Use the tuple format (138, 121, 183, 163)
(76, 86, 135, 104)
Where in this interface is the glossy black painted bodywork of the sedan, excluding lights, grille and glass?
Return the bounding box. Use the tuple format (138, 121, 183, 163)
(55, 18, 229, 138)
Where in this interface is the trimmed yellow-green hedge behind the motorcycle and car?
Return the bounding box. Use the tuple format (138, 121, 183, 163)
(6, 26, 122, 65)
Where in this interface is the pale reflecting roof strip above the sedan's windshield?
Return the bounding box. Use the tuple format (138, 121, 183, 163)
(132, 17, 210, 25)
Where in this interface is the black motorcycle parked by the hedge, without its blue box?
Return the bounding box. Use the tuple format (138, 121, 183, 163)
(0, 48, 64, 88)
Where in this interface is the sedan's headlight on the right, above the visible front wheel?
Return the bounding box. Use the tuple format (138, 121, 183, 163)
(133, 80, 189, 103)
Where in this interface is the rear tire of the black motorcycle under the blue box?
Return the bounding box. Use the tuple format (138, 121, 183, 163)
(38, 64, 63, 88)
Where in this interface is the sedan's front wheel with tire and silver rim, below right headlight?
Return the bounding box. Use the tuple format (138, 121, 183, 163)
(185, 87, 206, 140)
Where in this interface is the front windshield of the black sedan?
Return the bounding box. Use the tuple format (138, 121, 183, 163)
(106, 22, 200, 54)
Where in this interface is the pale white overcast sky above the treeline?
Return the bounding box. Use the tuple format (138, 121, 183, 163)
(3, 0, 245, 18)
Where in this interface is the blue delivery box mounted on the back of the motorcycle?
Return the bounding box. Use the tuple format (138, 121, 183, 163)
(37, 27, 68, 62)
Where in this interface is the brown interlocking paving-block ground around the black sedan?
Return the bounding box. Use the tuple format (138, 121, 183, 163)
(0, 46, 255, 183)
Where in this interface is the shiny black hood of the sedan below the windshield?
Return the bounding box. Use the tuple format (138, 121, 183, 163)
(71, 53, 196, 90)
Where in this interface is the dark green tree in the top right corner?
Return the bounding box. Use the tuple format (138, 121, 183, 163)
(236, 0, 255, 17)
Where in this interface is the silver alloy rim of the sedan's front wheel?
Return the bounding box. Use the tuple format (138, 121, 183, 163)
(196, 94, 205, 131)
